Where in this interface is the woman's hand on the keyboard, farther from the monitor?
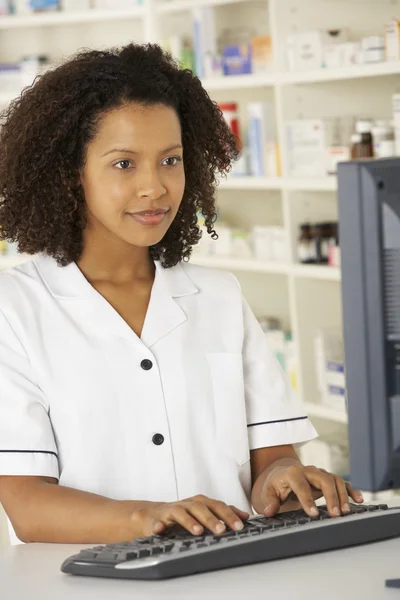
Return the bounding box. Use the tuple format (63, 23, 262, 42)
(133, 495, 250, 537)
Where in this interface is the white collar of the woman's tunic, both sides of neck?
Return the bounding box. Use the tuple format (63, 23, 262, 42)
(34, 254, 199, 298)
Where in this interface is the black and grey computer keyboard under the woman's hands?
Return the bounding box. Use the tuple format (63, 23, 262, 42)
(61, 504, 400, 579)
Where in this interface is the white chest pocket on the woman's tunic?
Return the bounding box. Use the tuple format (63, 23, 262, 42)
(207, 352, 250, 465)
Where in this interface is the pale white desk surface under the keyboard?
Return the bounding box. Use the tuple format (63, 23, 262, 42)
(0, 538, 400, 600)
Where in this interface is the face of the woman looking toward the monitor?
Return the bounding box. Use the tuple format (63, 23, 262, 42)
(81, 104, 185, 247)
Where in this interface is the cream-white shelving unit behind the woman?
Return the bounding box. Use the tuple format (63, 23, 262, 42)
(0, 0, 394, 446)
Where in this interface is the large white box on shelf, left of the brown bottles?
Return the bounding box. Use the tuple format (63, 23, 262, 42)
(286, 119, 326, 177)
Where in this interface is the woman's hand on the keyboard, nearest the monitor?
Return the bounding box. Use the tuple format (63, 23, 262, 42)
(262, 463, 364, 517)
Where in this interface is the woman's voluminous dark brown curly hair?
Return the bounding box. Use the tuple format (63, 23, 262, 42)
(0, 44, 238, 267)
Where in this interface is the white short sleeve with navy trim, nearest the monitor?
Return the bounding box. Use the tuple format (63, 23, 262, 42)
(242, 299, 318, 450)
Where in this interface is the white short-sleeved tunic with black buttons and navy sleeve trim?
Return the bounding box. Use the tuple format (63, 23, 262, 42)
(0, 255, 317, 540)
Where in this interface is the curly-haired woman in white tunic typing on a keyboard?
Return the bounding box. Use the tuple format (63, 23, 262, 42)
(0, 44, 362, 543)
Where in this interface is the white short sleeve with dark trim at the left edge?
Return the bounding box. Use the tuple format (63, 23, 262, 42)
(0, 312, 59, 479)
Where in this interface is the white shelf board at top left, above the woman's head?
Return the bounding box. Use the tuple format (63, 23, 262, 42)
(0, 6, 145, 29)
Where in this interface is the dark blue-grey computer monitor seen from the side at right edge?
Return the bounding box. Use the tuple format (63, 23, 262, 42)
(338, 158, 400, 491)
